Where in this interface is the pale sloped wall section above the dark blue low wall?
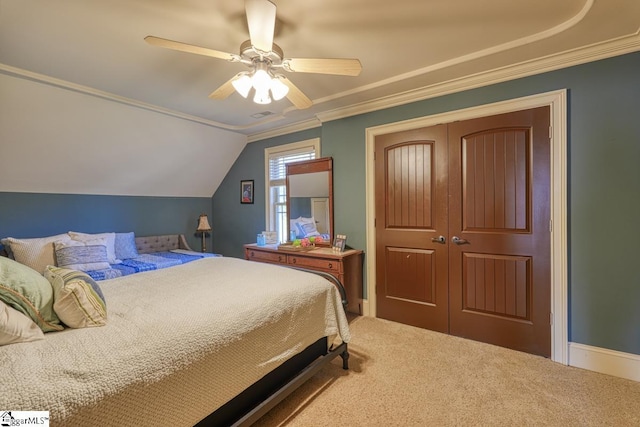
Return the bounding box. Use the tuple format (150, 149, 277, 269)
(0, 74, 246, 197)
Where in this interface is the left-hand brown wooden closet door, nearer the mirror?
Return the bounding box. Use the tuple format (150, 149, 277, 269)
(375, 125, 449, 332)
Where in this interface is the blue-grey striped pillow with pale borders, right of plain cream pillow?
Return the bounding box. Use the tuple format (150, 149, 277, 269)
(54, 239, 111, 271)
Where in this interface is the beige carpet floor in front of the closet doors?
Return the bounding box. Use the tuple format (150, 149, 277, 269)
(255, 317, 640, 427)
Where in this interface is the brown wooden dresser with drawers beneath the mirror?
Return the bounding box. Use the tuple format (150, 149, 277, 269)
(244, 243, 363, 314)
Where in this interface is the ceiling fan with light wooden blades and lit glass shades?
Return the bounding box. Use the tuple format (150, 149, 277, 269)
(144, 0, 362, 109)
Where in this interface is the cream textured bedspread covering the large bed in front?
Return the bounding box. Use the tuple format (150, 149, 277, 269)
(0, 258, 350, 426)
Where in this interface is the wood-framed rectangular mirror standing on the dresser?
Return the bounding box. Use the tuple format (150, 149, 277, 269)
(286, 157, 334, 246)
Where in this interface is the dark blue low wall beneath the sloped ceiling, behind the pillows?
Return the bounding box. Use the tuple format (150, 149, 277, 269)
(0, 192, 211, 251)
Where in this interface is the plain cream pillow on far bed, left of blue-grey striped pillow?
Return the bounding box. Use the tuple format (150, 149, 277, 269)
(2, 234, 71, 274)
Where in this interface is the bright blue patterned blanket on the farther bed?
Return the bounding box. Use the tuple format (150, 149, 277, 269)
(86, 251, 220, 280)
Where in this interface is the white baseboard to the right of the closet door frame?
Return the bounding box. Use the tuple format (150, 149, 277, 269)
(569, 342, 640, 382)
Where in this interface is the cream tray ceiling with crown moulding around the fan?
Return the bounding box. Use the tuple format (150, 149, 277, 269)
(0, 0, 640, 139)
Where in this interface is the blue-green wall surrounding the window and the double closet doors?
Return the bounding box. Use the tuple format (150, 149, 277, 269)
(213, 53, 640, 354)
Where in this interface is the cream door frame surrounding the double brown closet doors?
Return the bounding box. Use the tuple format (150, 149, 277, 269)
(363, 89, 569, 365)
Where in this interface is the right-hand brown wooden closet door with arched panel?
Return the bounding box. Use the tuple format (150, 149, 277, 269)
(449, 107, 551, 357)
